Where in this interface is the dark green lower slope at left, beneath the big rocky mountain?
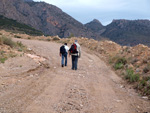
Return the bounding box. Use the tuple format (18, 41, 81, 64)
(0, 15, 43, 35)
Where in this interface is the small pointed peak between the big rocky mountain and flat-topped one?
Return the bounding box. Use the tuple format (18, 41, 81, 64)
(85, 19, 105, 35)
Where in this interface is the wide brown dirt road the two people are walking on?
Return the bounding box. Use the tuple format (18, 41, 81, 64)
(0, 39, 150, 113)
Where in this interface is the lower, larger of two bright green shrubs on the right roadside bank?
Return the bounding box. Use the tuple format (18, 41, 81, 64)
(125, 69, 140, 82)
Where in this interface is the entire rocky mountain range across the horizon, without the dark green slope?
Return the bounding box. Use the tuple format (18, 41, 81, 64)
(0, 0, 150, 46)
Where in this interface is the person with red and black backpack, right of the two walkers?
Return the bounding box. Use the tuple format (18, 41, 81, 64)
(69, 40, 81, 70)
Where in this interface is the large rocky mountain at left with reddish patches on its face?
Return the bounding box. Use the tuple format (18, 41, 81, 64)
(0, 0, 96, 38)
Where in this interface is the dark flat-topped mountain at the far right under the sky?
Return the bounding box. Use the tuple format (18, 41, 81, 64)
(101, 20, 150, 46)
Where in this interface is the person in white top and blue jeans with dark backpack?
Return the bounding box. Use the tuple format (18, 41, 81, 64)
(59, 43, 69, 67)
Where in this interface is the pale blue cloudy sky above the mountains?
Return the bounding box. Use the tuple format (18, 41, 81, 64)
(34, 0, 150, 25)
